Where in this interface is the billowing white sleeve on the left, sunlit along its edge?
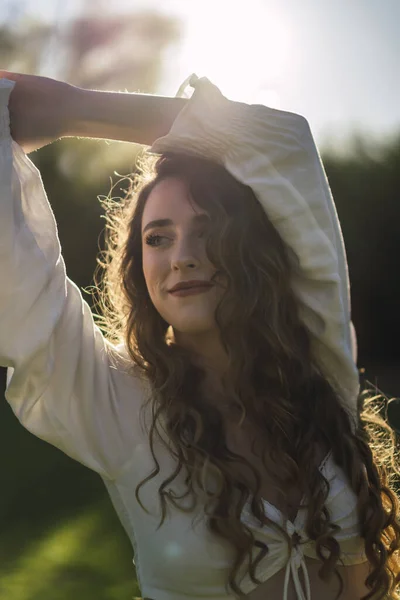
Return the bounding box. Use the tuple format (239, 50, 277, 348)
(0, 79, 147, 479)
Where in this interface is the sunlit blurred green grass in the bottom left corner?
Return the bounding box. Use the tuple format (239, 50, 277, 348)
(0, 501, 140, 600)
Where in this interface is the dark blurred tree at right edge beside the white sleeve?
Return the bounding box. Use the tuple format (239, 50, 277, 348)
(323, 135, 400, 370)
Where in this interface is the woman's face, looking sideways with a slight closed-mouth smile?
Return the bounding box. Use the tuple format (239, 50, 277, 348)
(142, 177, 222, 334)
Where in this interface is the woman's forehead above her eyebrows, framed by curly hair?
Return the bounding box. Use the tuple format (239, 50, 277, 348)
(142, 177, 207, 226)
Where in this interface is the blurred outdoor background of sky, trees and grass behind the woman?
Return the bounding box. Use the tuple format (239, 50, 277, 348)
(0, 0, 400, 600)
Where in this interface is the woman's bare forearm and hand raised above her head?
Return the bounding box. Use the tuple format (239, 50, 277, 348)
(0, 71, 187, 153)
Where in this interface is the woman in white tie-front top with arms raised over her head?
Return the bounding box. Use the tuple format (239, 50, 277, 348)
(0, 72, 400, 600)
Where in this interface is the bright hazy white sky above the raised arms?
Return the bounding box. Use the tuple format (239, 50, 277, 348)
(0, 0, 400, 152)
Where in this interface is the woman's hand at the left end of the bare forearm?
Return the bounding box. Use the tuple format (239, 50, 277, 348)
(0, 70, 80, 153)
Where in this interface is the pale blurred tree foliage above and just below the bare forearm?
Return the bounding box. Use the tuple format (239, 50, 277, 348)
(0, 0, 181, 182)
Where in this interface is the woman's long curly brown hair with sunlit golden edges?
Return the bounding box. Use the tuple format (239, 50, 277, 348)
(95, 154, 400, 600)
